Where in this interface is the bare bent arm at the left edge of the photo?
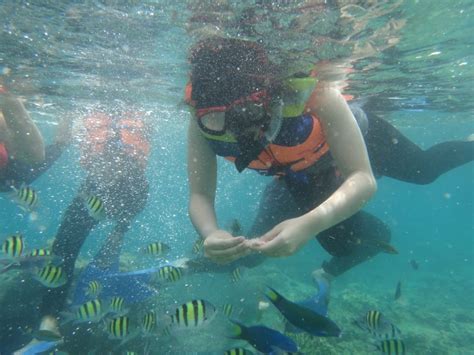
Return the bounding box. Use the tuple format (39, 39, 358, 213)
(0, 94, 45, 163)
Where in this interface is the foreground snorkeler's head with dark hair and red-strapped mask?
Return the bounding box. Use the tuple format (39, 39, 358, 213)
(190, 38, 286, 171)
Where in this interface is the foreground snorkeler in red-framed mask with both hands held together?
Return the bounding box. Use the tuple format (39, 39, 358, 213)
(186, 38, 474, 298)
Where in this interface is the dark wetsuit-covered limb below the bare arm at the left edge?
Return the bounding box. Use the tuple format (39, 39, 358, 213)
(0, 143, 66, 192)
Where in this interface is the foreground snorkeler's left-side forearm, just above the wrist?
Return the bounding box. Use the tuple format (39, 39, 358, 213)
(189, 193, 219, 238)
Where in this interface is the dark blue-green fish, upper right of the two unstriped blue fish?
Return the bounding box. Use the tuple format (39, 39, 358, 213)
(265, 287, 341, 337)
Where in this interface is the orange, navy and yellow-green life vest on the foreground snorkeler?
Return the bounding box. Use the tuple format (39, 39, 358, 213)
(185, 77, 329, 175)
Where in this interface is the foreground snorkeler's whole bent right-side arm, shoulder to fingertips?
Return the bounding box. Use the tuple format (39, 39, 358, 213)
(251, 88, 377, 256)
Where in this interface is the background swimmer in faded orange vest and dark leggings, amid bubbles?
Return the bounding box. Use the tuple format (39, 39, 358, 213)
(25, 112, 150, 350)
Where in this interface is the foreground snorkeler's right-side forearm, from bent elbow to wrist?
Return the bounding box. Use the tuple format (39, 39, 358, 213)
(301, 172, 377, 236)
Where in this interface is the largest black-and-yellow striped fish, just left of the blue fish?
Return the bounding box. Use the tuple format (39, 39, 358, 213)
(171, 300, 216, 329)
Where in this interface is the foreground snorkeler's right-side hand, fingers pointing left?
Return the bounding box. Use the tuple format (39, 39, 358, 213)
(248, 217, 315, 257)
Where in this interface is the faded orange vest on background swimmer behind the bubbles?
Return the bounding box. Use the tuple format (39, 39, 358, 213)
(81, 112, 150, 171)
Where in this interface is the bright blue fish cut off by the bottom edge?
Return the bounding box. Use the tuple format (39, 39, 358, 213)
(231, 320, 298, 354)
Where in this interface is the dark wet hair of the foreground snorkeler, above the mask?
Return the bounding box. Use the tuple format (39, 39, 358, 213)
(190, 38, 275, 108)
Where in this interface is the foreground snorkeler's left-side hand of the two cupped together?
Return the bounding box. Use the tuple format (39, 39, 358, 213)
(204, 229, 251, 264)
